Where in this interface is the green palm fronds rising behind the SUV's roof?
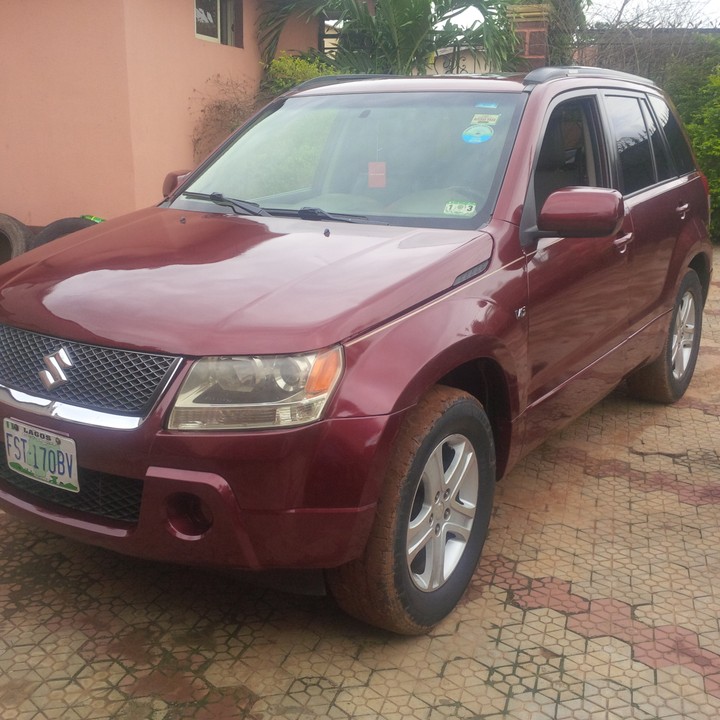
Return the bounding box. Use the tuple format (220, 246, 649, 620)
(260, 0, 517, 75)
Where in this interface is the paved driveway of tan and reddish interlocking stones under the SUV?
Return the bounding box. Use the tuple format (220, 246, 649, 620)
(0, 250, 720, 720)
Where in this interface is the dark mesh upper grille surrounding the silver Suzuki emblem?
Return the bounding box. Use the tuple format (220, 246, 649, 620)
(0, 325, 180, 417)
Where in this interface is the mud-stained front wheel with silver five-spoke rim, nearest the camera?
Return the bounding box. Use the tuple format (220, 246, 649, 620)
(326, 386, 495, 635)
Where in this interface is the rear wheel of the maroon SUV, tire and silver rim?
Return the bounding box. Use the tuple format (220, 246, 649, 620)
(627, 270, 703, 404)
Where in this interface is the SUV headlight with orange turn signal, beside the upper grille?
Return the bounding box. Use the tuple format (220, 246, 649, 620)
(168, 347, 343, 430)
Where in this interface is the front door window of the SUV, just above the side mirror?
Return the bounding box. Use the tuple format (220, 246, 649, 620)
(533, 98, 606, 210)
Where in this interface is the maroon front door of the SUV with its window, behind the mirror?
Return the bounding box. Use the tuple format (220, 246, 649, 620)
(524, 96, 631, 449)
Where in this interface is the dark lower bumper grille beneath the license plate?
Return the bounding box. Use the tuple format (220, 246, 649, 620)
(0, 464, 143, 524)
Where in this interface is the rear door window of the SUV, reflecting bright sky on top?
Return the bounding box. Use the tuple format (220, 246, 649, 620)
(606, 96, 656, 195)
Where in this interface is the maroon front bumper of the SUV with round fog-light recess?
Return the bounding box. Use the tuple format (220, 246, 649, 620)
(0, 404, 400, 570)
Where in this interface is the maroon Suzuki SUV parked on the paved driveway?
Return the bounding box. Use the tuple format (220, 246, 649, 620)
(0, 68, 711, 633)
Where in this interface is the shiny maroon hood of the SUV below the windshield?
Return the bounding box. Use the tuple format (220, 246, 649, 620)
(0, 208, 492, 356)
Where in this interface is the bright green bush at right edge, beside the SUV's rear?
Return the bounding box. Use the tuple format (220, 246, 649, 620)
(687, 66, 720, 242)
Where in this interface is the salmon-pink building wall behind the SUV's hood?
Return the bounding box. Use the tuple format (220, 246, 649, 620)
(0, 0, 316, 225)
